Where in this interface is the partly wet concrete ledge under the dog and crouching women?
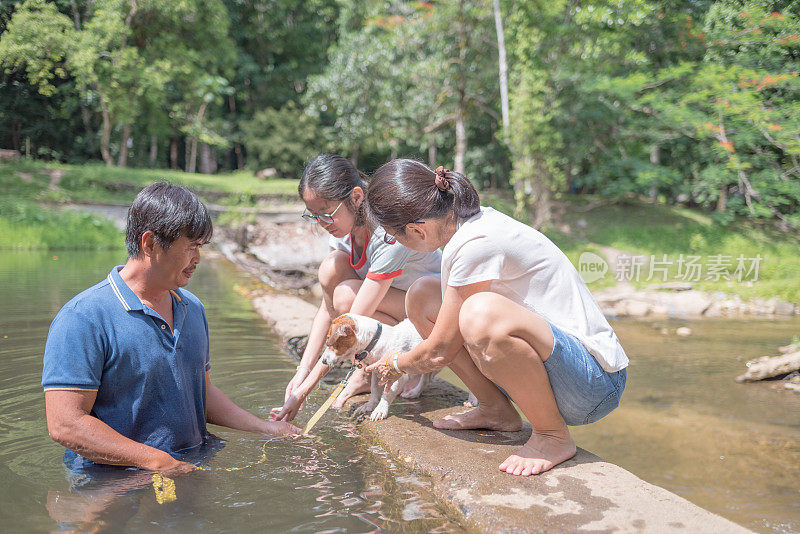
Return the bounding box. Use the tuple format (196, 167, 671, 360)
(228, 258, 749, 533)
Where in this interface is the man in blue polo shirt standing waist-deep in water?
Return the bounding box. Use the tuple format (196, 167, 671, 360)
(42, 183, 300, 473)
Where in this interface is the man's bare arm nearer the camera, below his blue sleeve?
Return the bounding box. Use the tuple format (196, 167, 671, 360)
(44, 390, 194, 472)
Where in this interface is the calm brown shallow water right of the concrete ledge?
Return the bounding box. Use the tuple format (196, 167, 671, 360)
(573, 319, 800, 532)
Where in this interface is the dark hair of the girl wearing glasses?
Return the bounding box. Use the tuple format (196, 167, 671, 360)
(297, 154, 368, 226)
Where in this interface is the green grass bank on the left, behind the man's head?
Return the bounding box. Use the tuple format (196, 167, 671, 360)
(0, 160, 297, 249)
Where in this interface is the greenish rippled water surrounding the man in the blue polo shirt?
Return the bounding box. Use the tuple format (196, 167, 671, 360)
(0, 252, 463, 532)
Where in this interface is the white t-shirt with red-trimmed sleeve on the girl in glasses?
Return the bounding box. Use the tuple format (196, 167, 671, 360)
(328, 226, 442, 291)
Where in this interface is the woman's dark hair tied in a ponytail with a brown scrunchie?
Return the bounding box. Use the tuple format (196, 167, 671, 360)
(366, 159, 480, 235)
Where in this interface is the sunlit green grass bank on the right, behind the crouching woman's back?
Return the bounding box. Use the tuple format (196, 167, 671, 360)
(482, 193, 800, 302)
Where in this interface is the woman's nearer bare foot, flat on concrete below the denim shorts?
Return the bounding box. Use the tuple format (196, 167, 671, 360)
(500, 429, 577, 477)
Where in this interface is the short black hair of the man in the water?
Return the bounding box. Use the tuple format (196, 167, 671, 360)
(125, 182, 214, 258)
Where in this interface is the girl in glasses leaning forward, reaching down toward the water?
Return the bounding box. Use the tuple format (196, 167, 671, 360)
(272, 154, 441, 421)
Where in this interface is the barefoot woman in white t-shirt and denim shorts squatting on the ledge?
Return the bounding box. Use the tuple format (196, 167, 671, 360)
(366, 159, 628, 476)
